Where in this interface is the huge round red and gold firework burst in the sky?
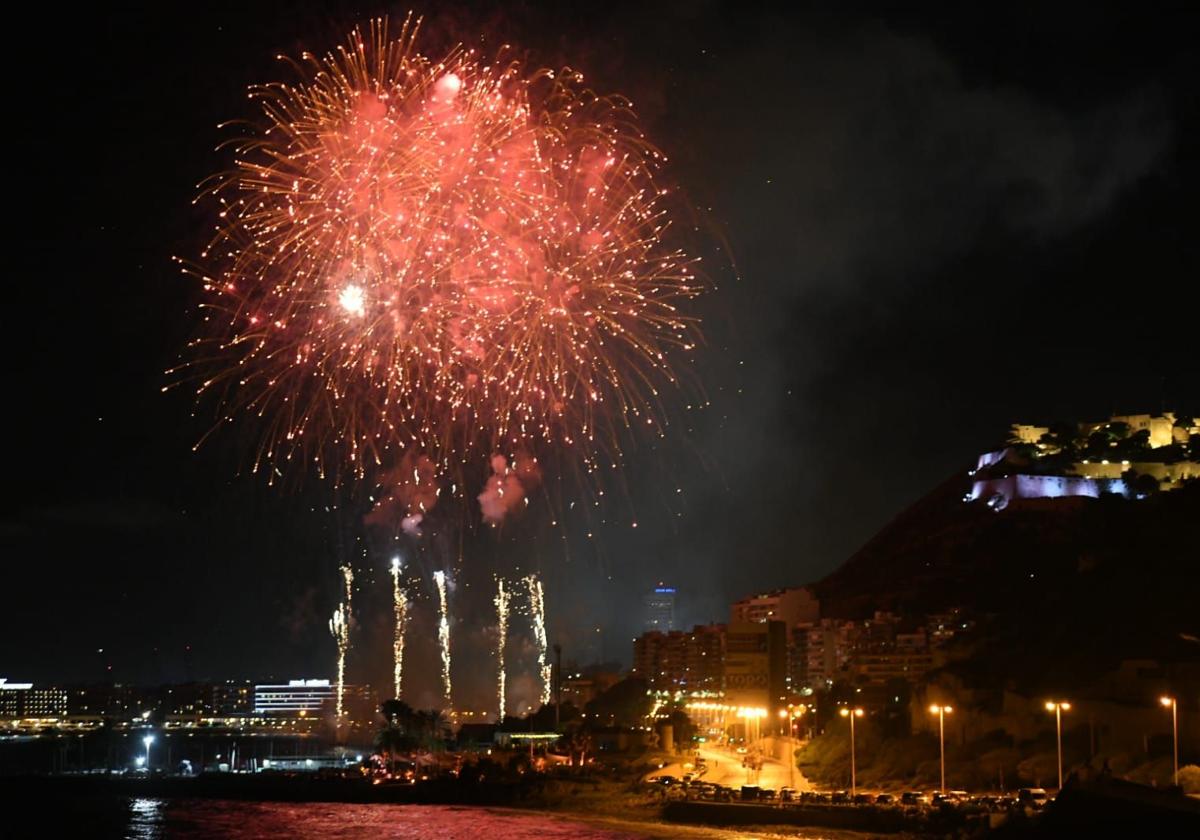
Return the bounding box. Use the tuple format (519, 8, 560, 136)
(173, 16, 701, 498)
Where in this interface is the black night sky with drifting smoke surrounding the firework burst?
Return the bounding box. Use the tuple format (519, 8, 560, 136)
(0, 2, 1200, 706)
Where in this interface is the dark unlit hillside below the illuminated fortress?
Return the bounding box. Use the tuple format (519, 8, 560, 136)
(815, 470, 1200, 684)
